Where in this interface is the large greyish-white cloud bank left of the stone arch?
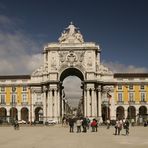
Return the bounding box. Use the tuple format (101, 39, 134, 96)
(0, 15, 42, 75)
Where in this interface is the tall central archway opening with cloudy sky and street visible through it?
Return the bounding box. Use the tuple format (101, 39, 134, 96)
(60, 68, 84, 116)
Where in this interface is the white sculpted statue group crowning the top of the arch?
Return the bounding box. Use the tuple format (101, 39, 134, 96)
(58, 22, 84, 43)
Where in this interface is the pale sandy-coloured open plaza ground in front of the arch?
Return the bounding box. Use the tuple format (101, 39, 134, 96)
(0, 125, 148, 148)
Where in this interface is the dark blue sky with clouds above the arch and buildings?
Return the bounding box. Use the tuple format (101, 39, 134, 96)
(0, 0, 148, 74)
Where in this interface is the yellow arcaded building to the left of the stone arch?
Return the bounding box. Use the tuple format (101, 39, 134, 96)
(0, 75, 30, 121)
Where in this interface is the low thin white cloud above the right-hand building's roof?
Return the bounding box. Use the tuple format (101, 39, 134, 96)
(103, 62, 148, 73)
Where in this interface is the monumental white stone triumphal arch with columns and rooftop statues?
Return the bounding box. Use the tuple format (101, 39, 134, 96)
(31, 23, 115, 121)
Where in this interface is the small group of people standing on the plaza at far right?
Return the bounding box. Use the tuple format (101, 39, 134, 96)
(115, 119, 129, 135)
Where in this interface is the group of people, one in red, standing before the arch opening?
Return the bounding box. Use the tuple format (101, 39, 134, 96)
(68, 118, 98, 133)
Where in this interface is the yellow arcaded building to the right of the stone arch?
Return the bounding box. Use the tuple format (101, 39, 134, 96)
(114, 73, 148, 122)
